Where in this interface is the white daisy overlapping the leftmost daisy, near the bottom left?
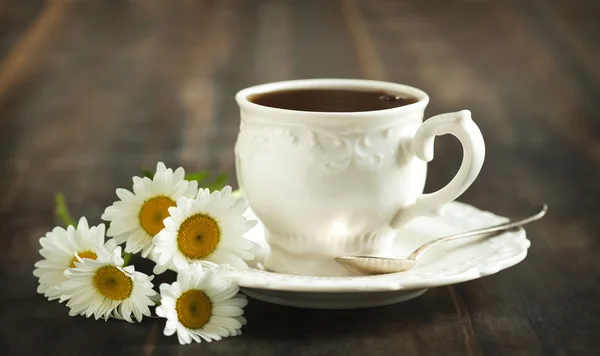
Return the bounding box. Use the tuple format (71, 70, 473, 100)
(58, 243, 156, 323)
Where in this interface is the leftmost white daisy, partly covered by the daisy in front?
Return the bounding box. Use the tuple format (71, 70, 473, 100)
(33, 218, 104, 300)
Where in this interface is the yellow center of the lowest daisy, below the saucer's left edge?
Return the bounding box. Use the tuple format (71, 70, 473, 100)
(175, 289, 212, 329)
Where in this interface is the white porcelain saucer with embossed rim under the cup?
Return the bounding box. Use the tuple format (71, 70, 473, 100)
(232, 202, 531, 309)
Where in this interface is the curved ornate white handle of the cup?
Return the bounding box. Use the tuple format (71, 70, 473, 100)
(390, 110, 485, 229)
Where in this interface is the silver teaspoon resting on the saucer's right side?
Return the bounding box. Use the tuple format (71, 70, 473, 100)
(335, 204, 548, 275)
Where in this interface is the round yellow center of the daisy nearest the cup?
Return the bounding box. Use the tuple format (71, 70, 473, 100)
(177, 214, 221, 260)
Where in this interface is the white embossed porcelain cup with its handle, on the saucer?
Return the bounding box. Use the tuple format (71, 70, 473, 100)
(235, 79, 485, 276)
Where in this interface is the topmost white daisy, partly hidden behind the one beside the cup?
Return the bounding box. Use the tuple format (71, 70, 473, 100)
(102, 162, 198, 258)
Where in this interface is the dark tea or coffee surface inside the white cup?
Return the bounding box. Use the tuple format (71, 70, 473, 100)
(249, 89, 418, 112)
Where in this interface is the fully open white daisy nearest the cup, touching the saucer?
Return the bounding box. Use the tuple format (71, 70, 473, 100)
(153, 186, 256, 273)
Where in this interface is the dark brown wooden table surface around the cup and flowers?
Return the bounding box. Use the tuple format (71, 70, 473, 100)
(0, 0, 600, 355)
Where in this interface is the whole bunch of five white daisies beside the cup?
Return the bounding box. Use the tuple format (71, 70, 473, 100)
(33, 163, 256, 344)
